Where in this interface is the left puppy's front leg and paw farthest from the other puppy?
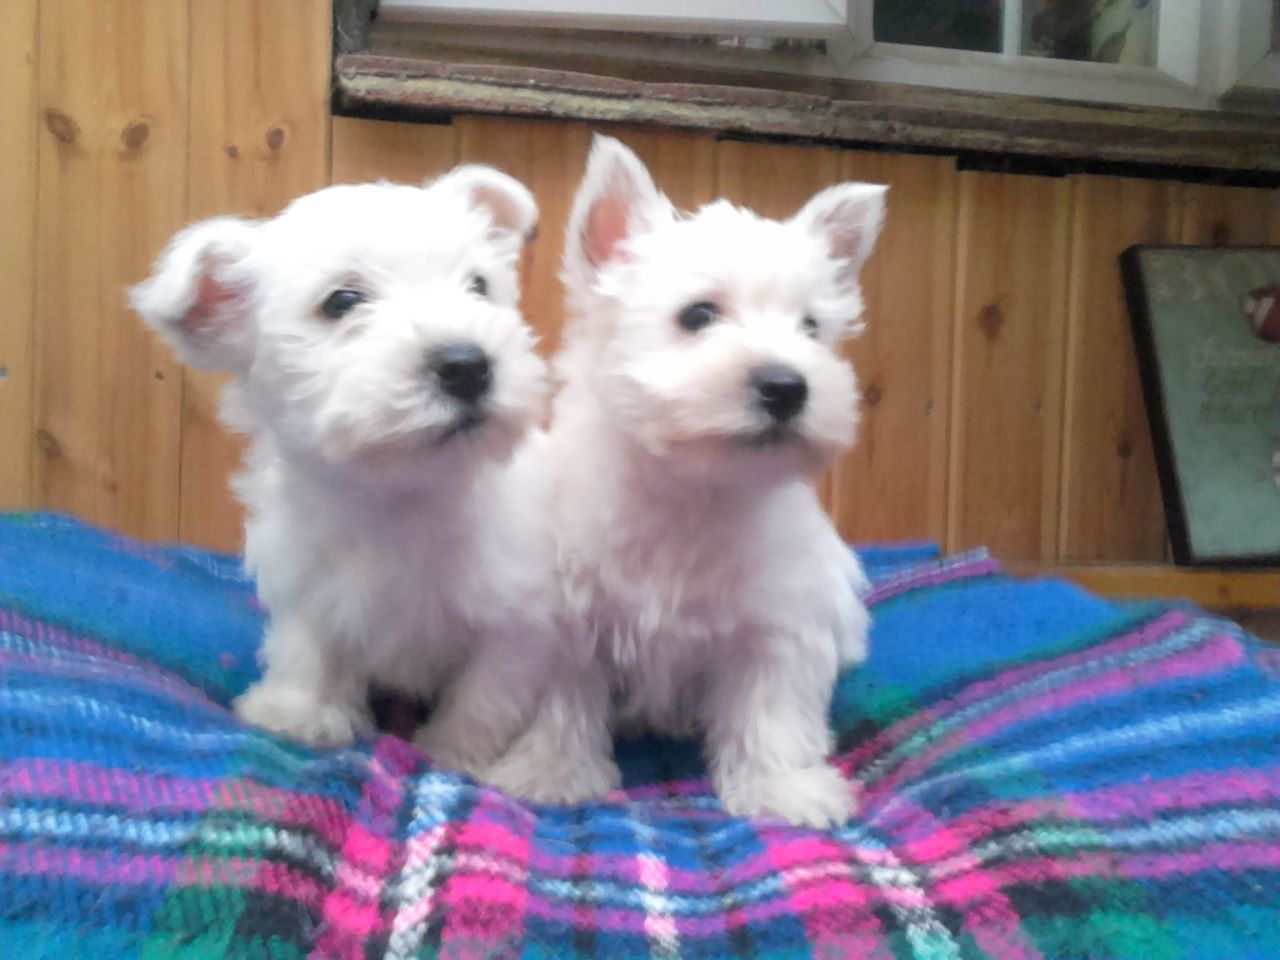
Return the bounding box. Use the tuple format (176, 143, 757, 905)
(236, 618, 370, 746)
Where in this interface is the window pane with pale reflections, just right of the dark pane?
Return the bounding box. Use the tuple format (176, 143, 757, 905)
(1021, 0, 1156, 67)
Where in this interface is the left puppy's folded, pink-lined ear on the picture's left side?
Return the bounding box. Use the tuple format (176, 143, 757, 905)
(129, 216, 257, 372)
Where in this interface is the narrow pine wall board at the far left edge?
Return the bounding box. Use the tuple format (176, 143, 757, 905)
(0, 0, 37, 509)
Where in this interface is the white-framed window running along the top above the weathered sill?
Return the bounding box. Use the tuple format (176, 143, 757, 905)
(383, 0, 1280, 109)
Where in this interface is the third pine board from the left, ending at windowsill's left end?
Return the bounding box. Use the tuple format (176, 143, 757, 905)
(179, 0, 330, 549)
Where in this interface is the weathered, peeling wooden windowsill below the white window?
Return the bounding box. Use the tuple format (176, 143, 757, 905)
(334, 28, 1280, 177)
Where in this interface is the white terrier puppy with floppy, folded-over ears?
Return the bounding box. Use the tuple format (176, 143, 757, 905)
(133, 166, 561, 773)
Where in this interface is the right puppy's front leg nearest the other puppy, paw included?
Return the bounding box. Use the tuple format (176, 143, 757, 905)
(483, 662, 622, 804)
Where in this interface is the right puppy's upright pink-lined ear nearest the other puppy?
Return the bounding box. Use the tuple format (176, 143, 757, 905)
(564, 134, 672, 289)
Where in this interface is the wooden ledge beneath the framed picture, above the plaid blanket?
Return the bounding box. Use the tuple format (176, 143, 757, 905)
(1010, 563, 1280, 609)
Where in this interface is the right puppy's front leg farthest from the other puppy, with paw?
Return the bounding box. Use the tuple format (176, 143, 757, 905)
(707, 637, 855, 827)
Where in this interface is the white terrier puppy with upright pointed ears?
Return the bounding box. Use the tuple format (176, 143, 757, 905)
(490, 137, 884, 826)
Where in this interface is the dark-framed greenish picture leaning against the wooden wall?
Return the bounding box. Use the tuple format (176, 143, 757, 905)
(1120, 247, 1280, 566)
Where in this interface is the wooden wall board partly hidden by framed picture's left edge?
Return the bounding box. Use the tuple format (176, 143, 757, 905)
(1059, 177, 1181, 561)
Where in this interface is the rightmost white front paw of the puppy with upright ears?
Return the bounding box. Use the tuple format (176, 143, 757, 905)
(716, 763, 858, 829)
